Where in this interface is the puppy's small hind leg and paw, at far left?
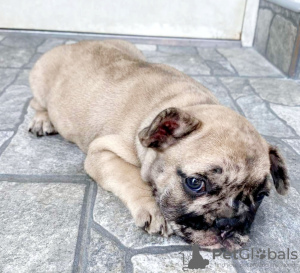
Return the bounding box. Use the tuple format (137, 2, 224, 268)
(28, 98, 57, 137)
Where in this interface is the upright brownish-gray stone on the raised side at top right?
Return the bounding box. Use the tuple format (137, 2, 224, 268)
(267, 15, 297, 73)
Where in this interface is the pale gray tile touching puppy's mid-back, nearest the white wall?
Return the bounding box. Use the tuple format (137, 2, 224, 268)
(146, 52, 210, 76)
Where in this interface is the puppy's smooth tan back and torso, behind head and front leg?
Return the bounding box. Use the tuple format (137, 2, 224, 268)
(30, 40, 217, 151)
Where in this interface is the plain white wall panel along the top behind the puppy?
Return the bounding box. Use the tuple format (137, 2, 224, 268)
(0, 0, 246, 39)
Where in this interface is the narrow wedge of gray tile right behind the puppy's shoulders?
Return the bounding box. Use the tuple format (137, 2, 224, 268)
(193, 77, 238, 112)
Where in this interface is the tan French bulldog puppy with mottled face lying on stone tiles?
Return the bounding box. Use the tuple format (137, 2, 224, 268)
(29, 40, 289, 250)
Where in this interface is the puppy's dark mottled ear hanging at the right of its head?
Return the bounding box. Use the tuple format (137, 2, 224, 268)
(269, 146, 290, 195)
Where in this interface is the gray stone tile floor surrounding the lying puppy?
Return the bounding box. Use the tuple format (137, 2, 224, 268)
(0, 32, 300, 273)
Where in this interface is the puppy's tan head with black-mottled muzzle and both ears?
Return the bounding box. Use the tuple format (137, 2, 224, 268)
(139, 105, 289, 250)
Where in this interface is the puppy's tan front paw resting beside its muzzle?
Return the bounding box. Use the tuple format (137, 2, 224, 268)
(133, 200, 173, 237)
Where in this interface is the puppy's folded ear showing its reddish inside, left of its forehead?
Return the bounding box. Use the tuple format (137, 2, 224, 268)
(139, 108, 201, 150)
